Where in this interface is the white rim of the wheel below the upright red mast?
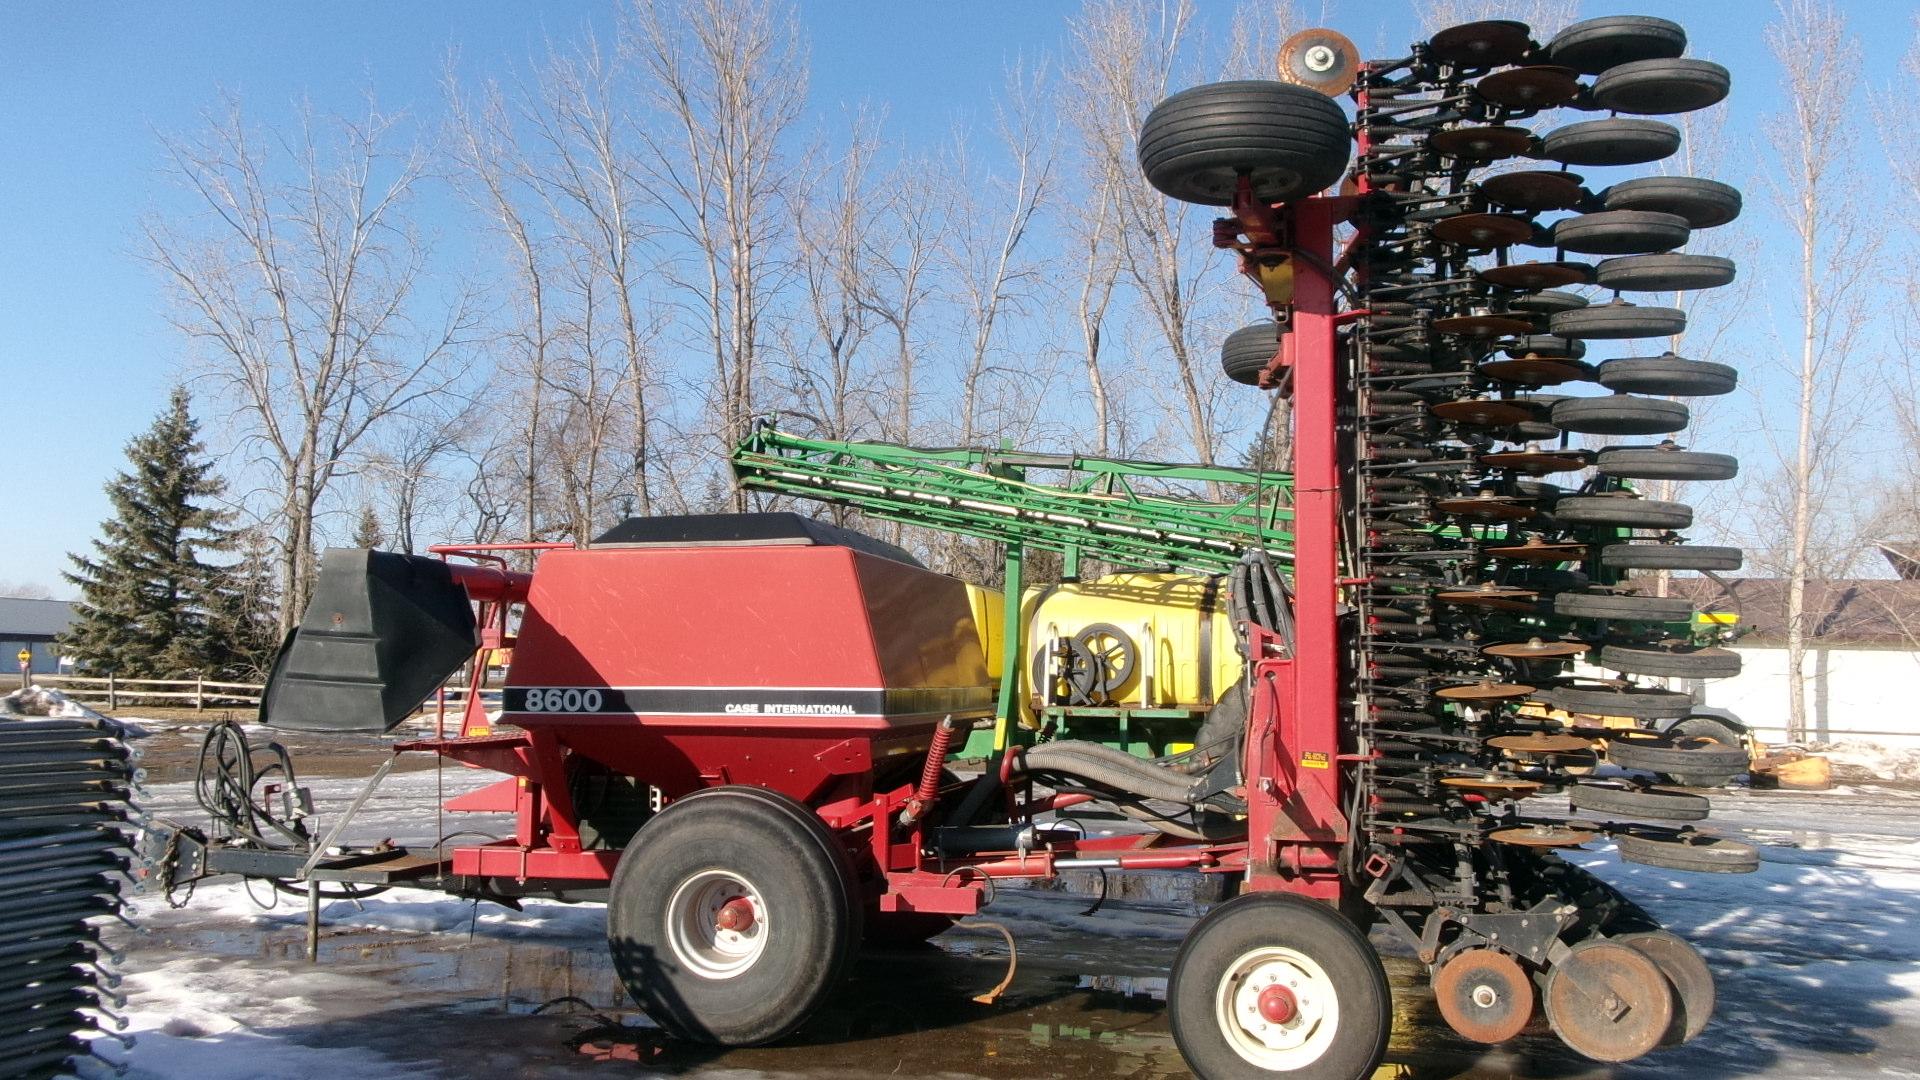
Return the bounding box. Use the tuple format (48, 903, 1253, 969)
(1213, 945, 1340, 1072)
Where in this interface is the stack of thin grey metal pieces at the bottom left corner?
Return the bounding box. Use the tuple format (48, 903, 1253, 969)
(0, 717, 136, 1080)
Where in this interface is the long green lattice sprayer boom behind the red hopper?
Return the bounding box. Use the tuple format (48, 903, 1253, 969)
(733, 425, 1294, 573)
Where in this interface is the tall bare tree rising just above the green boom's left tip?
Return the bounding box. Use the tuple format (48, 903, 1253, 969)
(622, 0, 806, 509)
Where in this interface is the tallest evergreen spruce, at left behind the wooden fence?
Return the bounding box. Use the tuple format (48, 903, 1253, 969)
(60, 386, 238, 678)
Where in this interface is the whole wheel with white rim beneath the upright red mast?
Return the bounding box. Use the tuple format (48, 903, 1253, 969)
(1167, 892, 1394, 1080)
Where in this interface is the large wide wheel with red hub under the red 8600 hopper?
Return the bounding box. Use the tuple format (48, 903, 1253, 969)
(607, 786, 860, 1045)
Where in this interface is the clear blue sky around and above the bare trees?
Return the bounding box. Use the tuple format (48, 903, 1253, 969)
(0, 0, 1912, 596)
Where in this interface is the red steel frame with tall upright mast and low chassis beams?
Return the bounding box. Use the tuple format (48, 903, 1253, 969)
(385, 191, 1357, 915)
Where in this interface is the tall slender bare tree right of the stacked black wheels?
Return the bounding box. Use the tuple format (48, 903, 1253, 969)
(1766, 0, 1878, 740)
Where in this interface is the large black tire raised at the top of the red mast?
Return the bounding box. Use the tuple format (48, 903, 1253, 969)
(1139, 79, 1354, 206)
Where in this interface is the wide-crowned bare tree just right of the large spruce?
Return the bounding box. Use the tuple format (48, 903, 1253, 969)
(144, 98, 474, 630)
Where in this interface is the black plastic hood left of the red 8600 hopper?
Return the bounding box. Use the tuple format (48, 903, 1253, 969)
(259, 548, 478, 734)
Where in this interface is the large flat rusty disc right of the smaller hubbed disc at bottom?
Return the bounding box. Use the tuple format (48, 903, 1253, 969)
(1546, 940, 1674, 1061)
